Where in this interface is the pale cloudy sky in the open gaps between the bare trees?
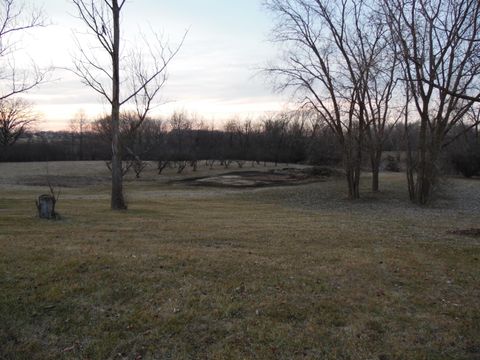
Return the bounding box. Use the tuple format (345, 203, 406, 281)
(15, 0, 286, 129)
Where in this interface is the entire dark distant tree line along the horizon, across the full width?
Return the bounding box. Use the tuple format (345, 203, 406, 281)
(3, 111, 480, 177)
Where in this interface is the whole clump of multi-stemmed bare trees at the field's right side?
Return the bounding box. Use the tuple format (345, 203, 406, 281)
(267, 0, 480, 204)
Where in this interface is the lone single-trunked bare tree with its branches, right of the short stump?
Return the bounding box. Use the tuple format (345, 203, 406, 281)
(72, 0, 186, 210)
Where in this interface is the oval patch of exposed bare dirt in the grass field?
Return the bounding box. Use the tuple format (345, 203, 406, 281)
(181, 167, 338, 188)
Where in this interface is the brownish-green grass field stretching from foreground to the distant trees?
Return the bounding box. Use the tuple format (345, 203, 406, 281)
(0, 162, 480, 360)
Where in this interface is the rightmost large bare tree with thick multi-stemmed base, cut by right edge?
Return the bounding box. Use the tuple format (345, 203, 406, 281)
(383, 0, 480, 204)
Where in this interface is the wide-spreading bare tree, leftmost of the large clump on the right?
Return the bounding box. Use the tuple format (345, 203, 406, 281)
(266, 0, 392, 199)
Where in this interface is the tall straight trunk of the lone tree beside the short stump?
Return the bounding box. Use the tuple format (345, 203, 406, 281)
(111, 0, 127, 210)
